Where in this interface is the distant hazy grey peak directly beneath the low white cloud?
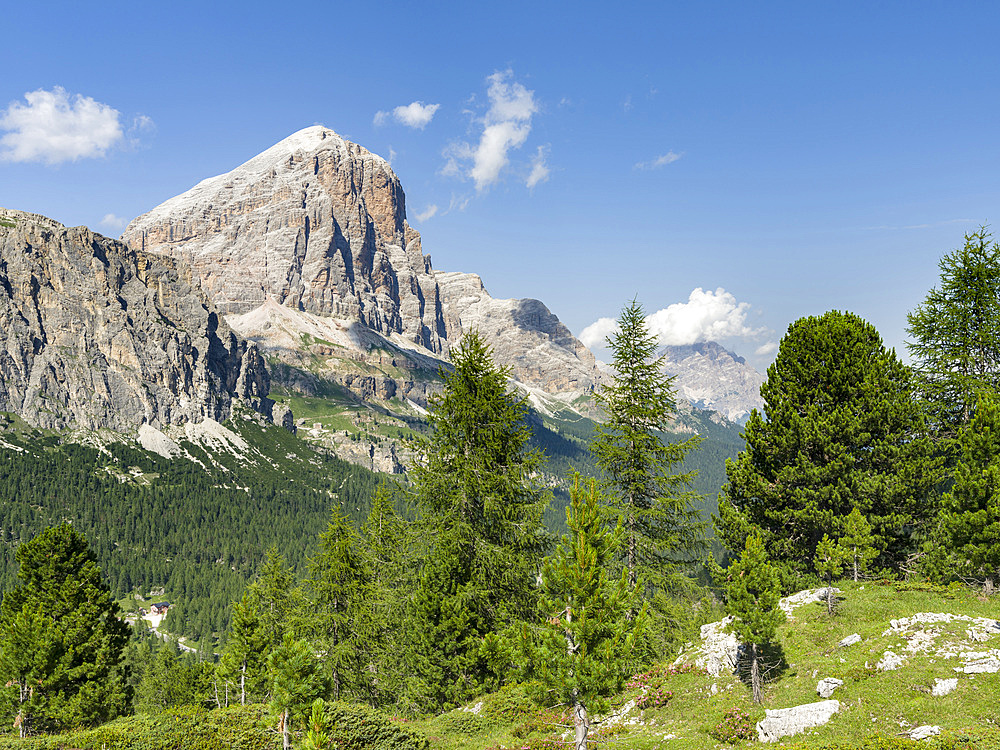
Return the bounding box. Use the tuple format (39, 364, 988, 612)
(660, 341, 766, 422)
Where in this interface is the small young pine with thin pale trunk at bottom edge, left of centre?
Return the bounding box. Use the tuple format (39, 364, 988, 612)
(267, 633, 326, 750)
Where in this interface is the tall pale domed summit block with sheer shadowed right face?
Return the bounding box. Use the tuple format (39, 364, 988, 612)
(122, 126, 445, 352)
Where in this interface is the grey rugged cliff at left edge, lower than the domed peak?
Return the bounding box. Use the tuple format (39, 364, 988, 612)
(0, 209, 272, 432)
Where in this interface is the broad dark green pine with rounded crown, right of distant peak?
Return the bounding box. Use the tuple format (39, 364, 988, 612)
(716, 311, 940, 585)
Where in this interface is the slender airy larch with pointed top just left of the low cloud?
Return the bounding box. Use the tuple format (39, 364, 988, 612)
(591, 300, 703, 590)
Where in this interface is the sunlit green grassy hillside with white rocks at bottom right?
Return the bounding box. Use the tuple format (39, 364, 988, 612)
(408, 582, 1000, 750)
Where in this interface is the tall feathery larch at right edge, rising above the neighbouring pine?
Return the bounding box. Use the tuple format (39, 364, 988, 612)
(907, 227, 1000, 438)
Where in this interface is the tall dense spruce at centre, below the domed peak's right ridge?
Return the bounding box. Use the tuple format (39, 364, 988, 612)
(408, 332, 549, 702)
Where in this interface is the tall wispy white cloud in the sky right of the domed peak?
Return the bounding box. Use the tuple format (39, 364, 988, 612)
(442, 70, 548, 192)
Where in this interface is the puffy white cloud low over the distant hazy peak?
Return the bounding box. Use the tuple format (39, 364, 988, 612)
(646, 287, 769, 345)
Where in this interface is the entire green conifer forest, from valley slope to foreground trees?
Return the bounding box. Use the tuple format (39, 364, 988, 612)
(0, 228, 1000, 750)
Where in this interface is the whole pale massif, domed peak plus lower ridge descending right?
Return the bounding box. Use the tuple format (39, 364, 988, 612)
(122, 126, 597, 402)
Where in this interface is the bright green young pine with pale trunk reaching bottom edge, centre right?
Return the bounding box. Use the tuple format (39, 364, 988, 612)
(522, 476, 646, 750)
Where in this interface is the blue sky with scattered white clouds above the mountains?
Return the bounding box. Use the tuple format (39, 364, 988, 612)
(0, 2, 1000, 368)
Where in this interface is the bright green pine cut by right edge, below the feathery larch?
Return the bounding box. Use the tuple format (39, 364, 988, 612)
(928, 394, 1000, 593)
